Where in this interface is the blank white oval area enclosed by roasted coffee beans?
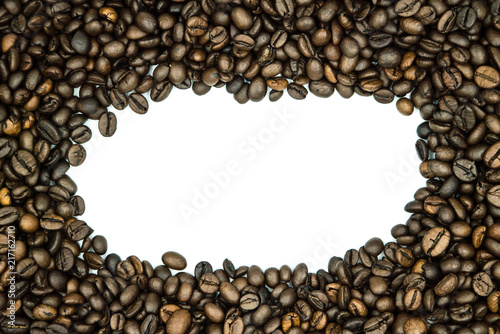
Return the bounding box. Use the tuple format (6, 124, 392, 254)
(69, 88, 425, 272)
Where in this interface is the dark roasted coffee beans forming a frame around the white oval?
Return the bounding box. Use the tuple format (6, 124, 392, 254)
(0, 0, 500, 334)
